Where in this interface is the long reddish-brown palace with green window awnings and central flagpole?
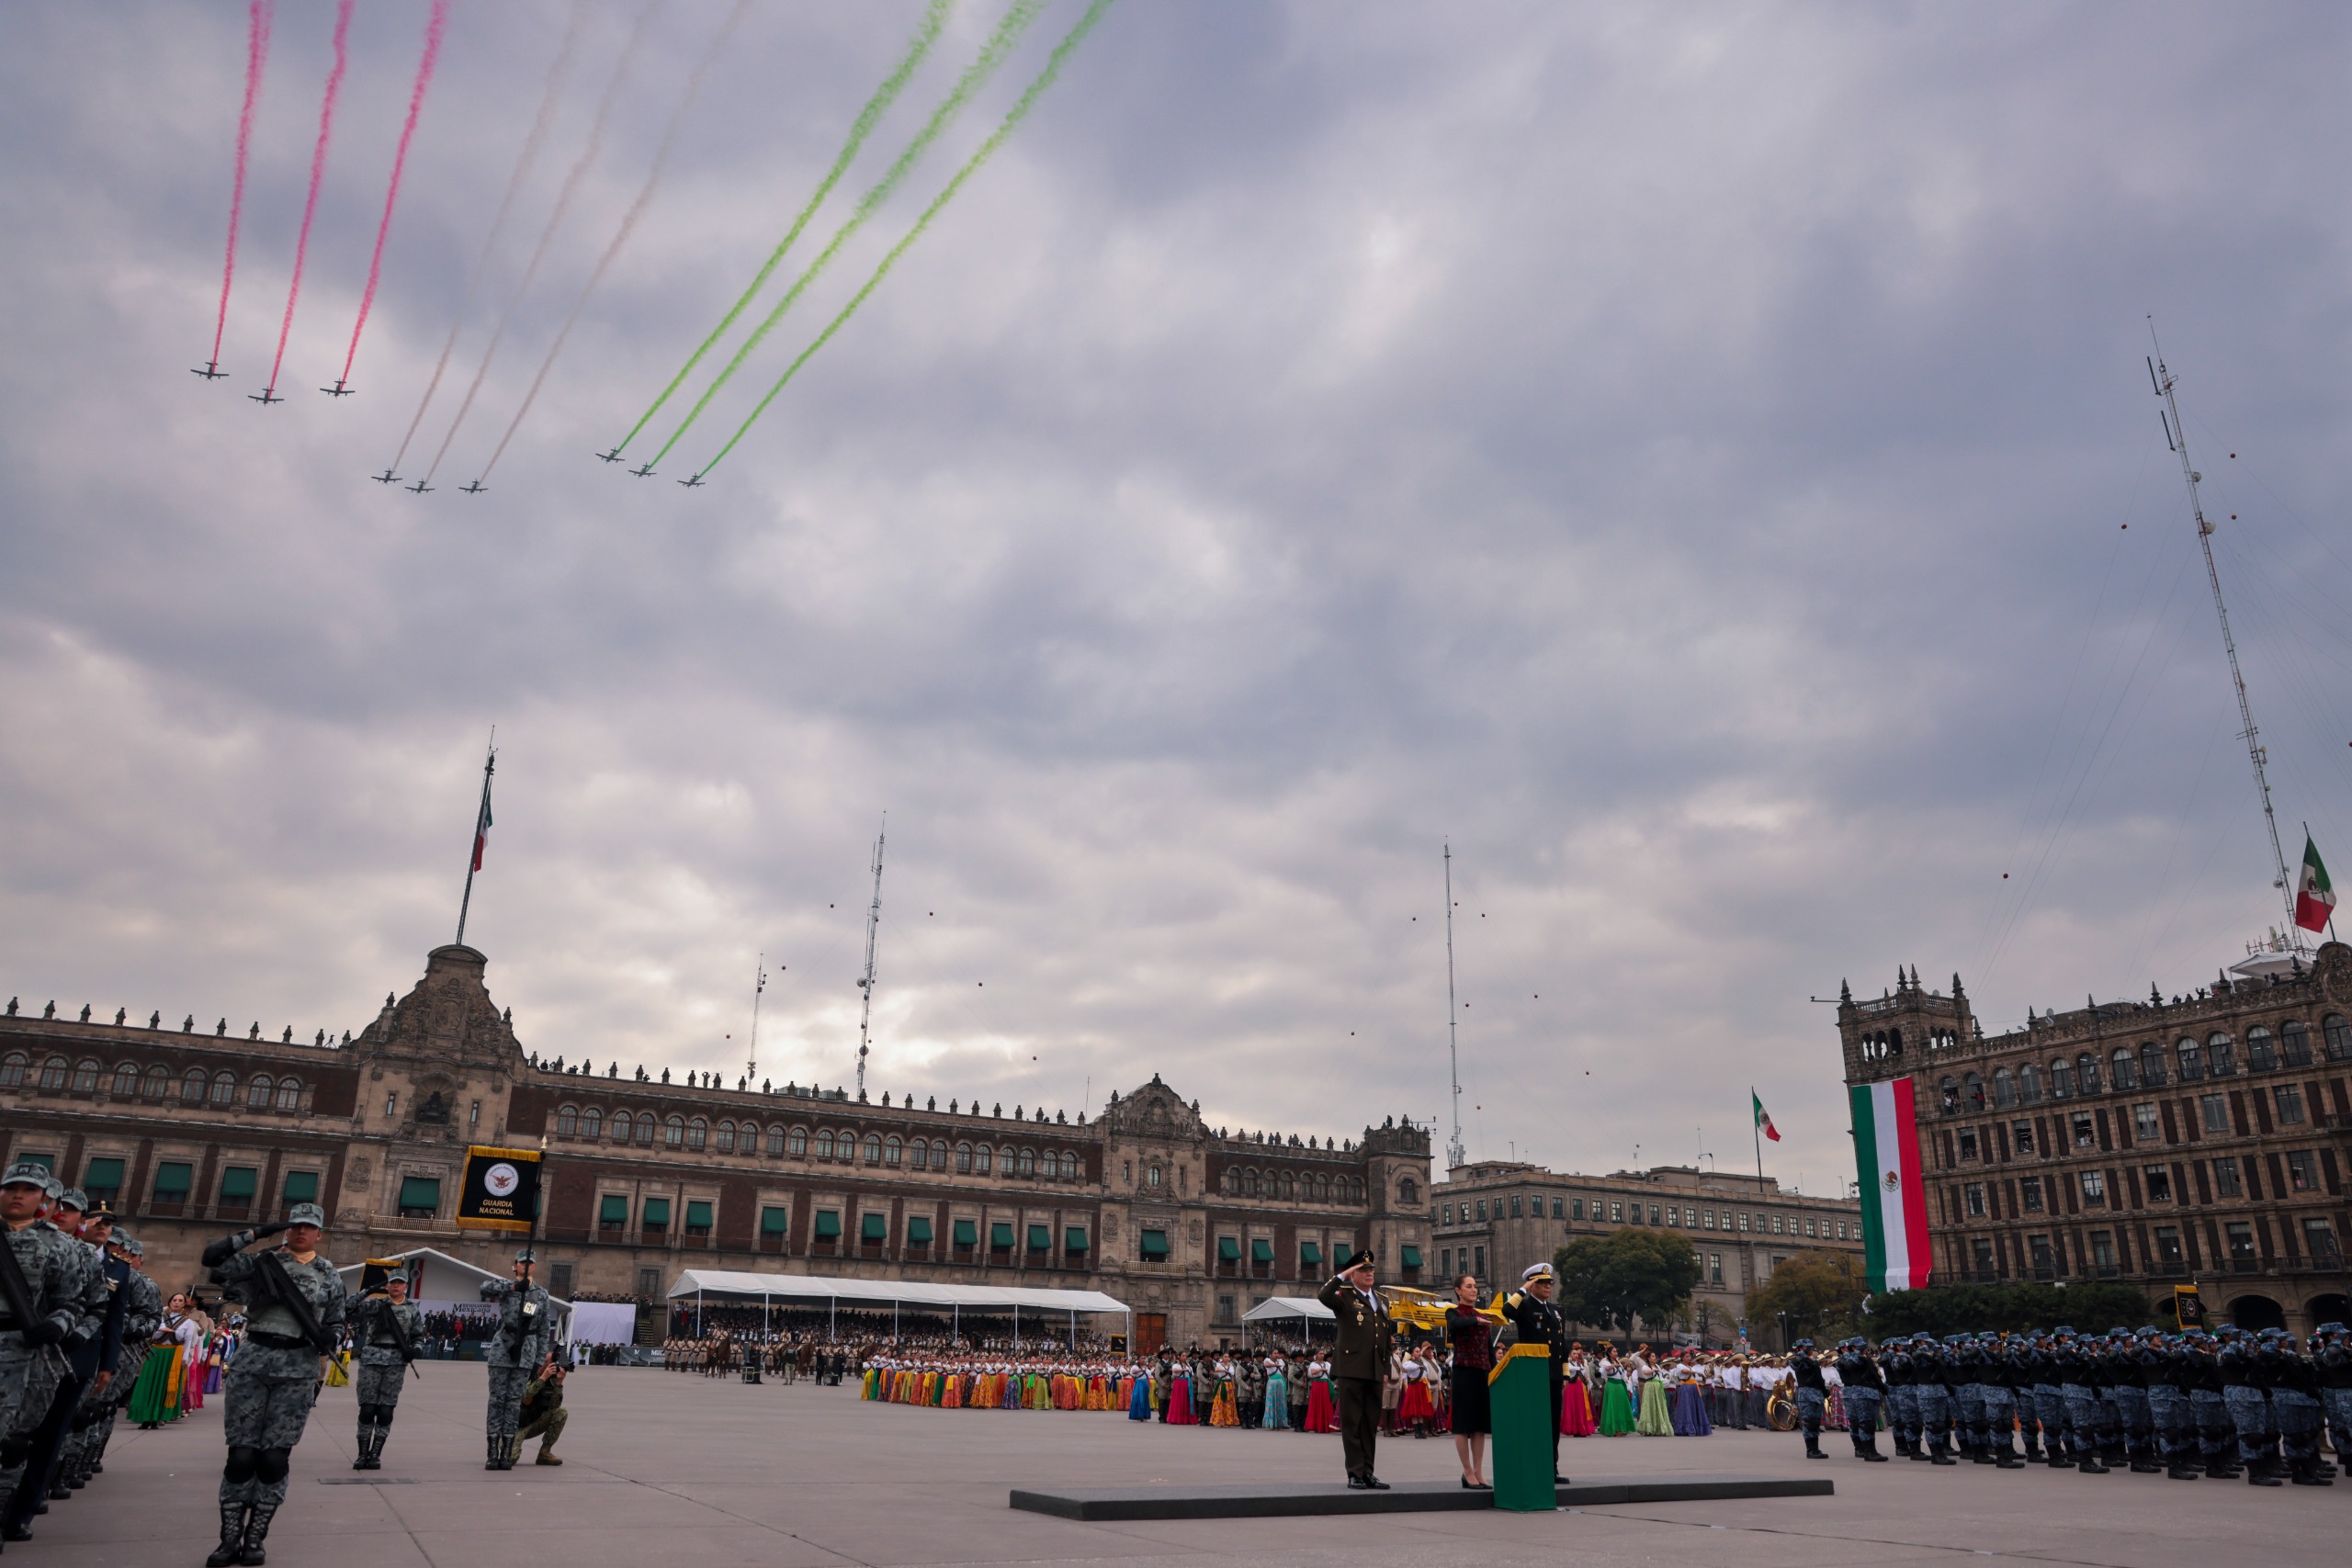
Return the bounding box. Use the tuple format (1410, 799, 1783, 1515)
(0, 947, 1435, 1347)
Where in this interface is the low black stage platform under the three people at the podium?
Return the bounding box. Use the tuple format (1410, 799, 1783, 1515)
(1012, 1476, 1837, 1518)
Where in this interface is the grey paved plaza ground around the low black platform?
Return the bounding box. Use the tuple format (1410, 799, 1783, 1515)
(22, 1361, 2352, 1568)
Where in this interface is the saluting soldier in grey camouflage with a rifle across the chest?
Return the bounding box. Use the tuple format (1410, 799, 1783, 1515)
(205, 1203, 344, 1568)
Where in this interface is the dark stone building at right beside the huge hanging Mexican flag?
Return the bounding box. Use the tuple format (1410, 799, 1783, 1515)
(1837, 942, 2352, 1333)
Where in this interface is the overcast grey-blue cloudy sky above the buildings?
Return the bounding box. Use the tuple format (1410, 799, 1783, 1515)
(0, 0, 2352, 1192)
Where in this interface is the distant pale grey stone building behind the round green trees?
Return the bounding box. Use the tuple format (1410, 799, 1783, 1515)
(1430, 1159, 1863, 1345)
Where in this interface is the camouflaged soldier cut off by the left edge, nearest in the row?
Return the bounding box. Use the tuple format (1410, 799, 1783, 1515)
(0, 1161, 99, 1540)
